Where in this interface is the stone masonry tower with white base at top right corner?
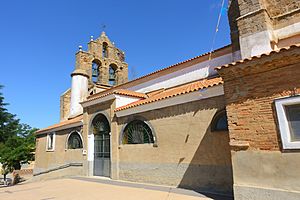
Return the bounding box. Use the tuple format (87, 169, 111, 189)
(228, 0, 300, 58)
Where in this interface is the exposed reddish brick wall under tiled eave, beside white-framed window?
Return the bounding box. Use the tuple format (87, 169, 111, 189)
(219, 47, 300, 150)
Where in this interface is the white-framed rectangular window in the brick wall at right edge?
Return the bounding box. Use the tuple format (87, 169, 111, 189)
(275, 96, 300, 149)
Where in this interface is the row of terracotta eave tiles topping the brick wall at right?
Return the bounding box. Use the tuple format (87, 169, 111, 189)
(215, 44, 300, 70)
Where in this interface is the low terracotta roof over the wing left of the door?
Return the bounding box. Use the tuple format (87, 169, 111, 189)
(35, 115, 83, 134)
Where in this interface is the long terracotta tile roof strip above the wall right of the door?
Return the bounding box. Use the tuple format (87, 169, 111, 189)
(115, 77, 223, 112)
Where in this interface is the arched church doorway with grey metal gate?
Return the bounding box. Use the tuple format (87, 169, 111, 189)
(92, 114, 110, 177)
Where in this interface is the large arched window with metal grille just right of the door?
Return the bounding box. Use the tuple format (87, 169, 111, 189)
(122, 120, 154, 144)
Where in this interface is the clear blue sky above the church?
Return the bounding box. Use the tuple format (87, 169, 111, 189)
(0, 0, 230, 128)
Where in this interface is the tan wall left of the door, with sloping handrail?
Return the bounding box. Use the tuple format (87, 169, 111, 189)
(33, 127, 86, 179)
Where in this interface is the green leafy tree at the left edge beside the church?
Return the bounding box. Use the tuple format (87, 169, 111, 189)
(0, 85, 37, 184)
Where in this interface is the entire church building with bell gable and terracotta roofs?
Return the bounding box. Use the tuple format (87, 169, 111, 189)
(34, 0, 300, 199)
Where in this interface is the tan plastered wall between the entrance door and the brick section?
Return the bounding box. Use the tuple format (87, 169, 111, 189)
(117, 96, 232, 194)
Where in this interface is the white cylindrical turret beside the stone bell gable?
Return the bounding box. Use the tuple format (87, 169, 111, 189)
(69, 69, 89, 118)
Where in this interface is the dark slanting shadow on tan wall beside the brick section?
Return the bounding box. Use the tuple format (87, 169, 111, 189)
(178, 126, 233, 199)
